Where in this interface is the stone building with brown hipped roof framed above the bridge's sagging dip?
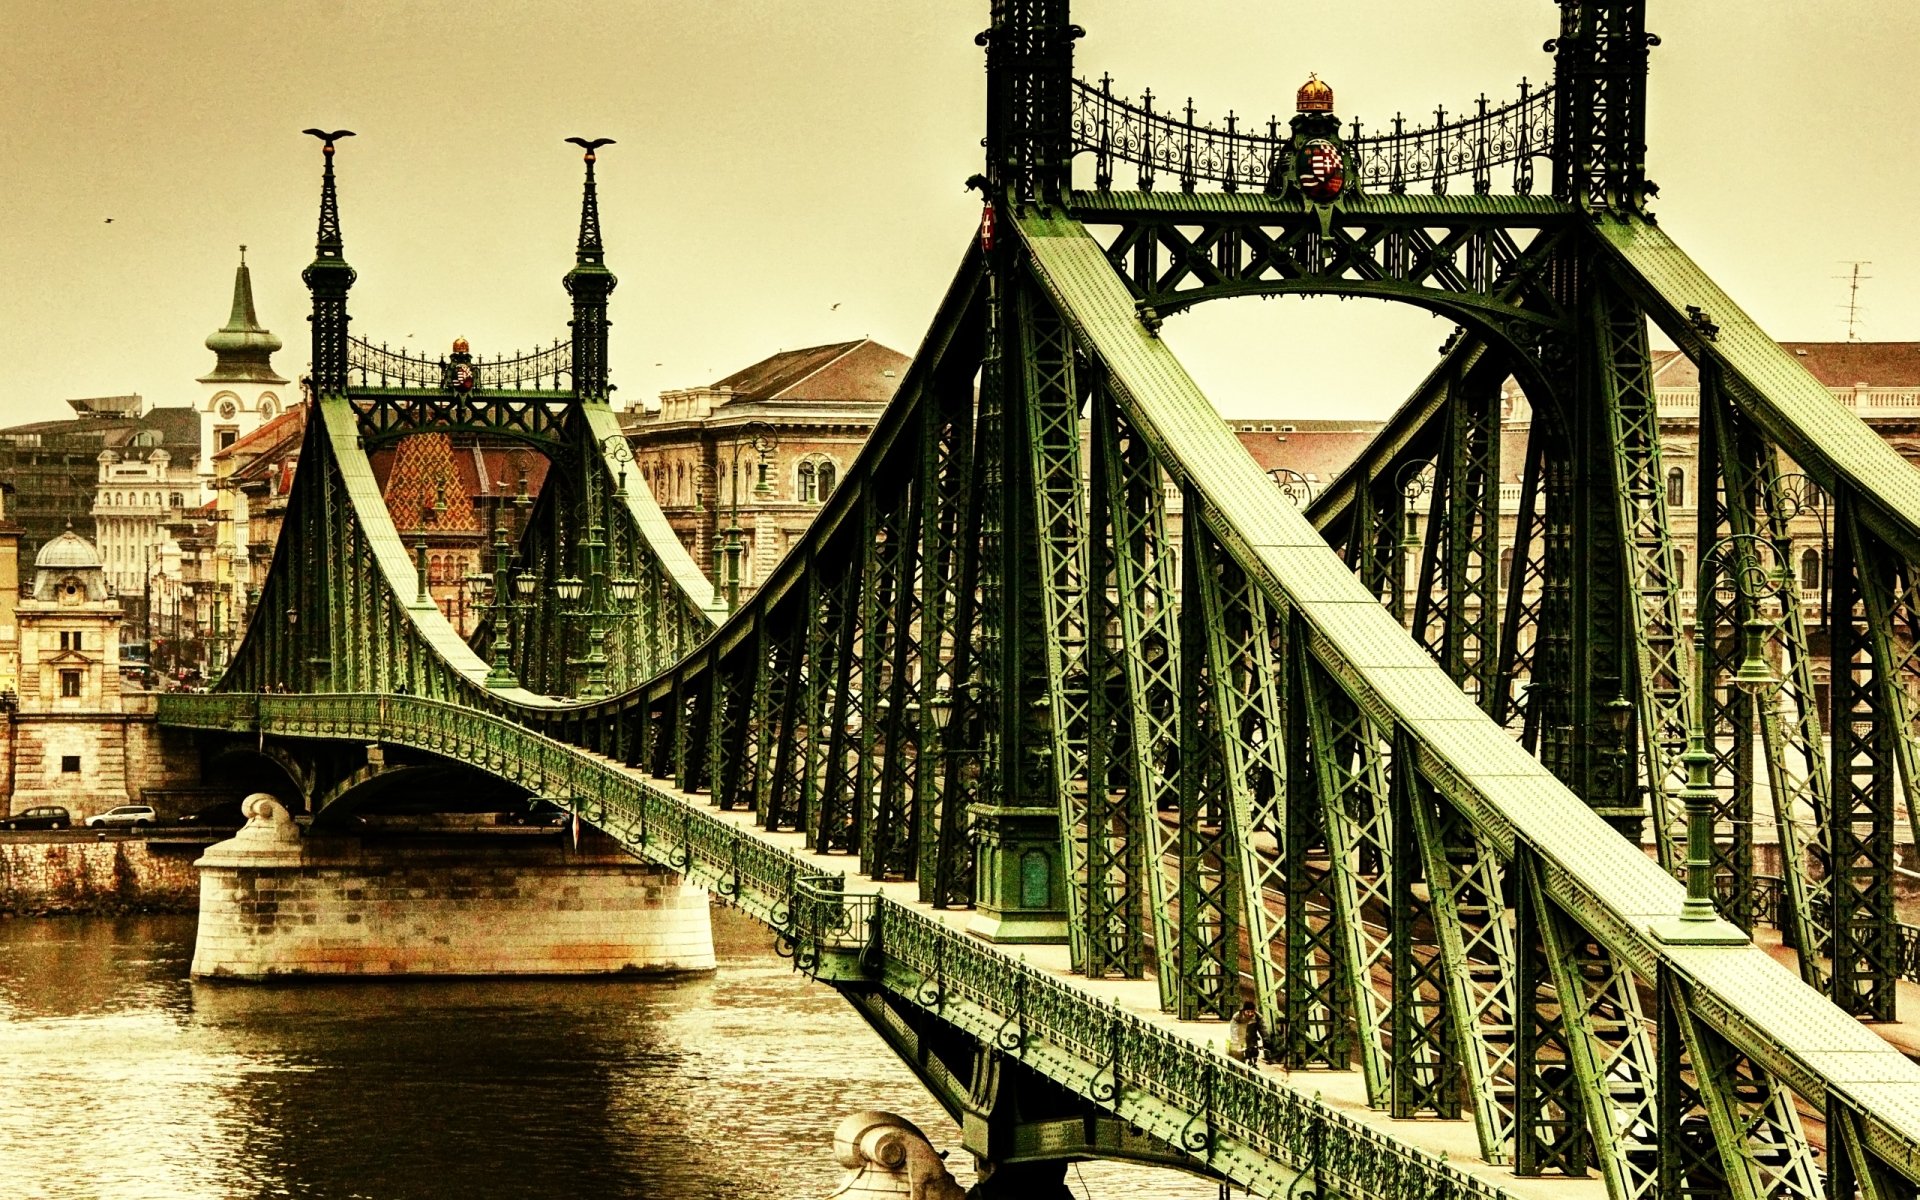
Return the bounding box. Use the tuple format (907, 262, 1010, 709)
(622, 338, 908, 595)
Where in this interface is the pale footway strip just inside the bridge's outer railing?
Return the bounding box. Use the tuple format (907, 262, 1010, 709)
(601, 758, 1607, 1200)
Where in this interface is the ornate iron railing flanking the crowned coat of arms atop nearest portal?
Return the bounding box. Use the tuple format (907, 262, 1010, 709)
(1071, 75, 1553, 196)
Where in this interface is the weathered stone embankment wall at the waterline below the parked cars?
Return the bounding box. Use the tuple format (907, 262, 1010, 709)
(0, 841, 204, 916)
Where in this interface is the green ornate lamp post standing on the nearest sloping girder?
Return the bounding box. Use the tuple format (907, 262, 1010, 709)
(1653, 534, 1791, 945)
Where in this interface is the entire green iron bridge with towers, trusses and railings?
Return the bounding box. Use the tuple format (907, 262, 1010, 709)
(161, 9, 1920, 1200)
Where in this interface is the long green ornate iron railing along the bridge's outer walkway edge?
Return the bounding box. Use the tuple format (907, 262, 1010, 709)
(159, 693, 1511, 1200)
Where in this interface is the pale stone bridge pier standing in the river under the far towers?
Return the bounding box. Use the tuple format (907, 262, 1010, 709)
(192, 793, 714, 979)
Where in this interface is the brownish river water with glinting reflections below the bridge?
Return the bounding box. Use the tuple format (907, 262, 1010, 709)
(0, 910, 1219, 1200)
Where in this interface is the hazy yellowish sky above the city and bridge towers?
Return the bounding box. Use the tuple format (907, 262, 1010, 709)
(0, 0, 1920, 424)
